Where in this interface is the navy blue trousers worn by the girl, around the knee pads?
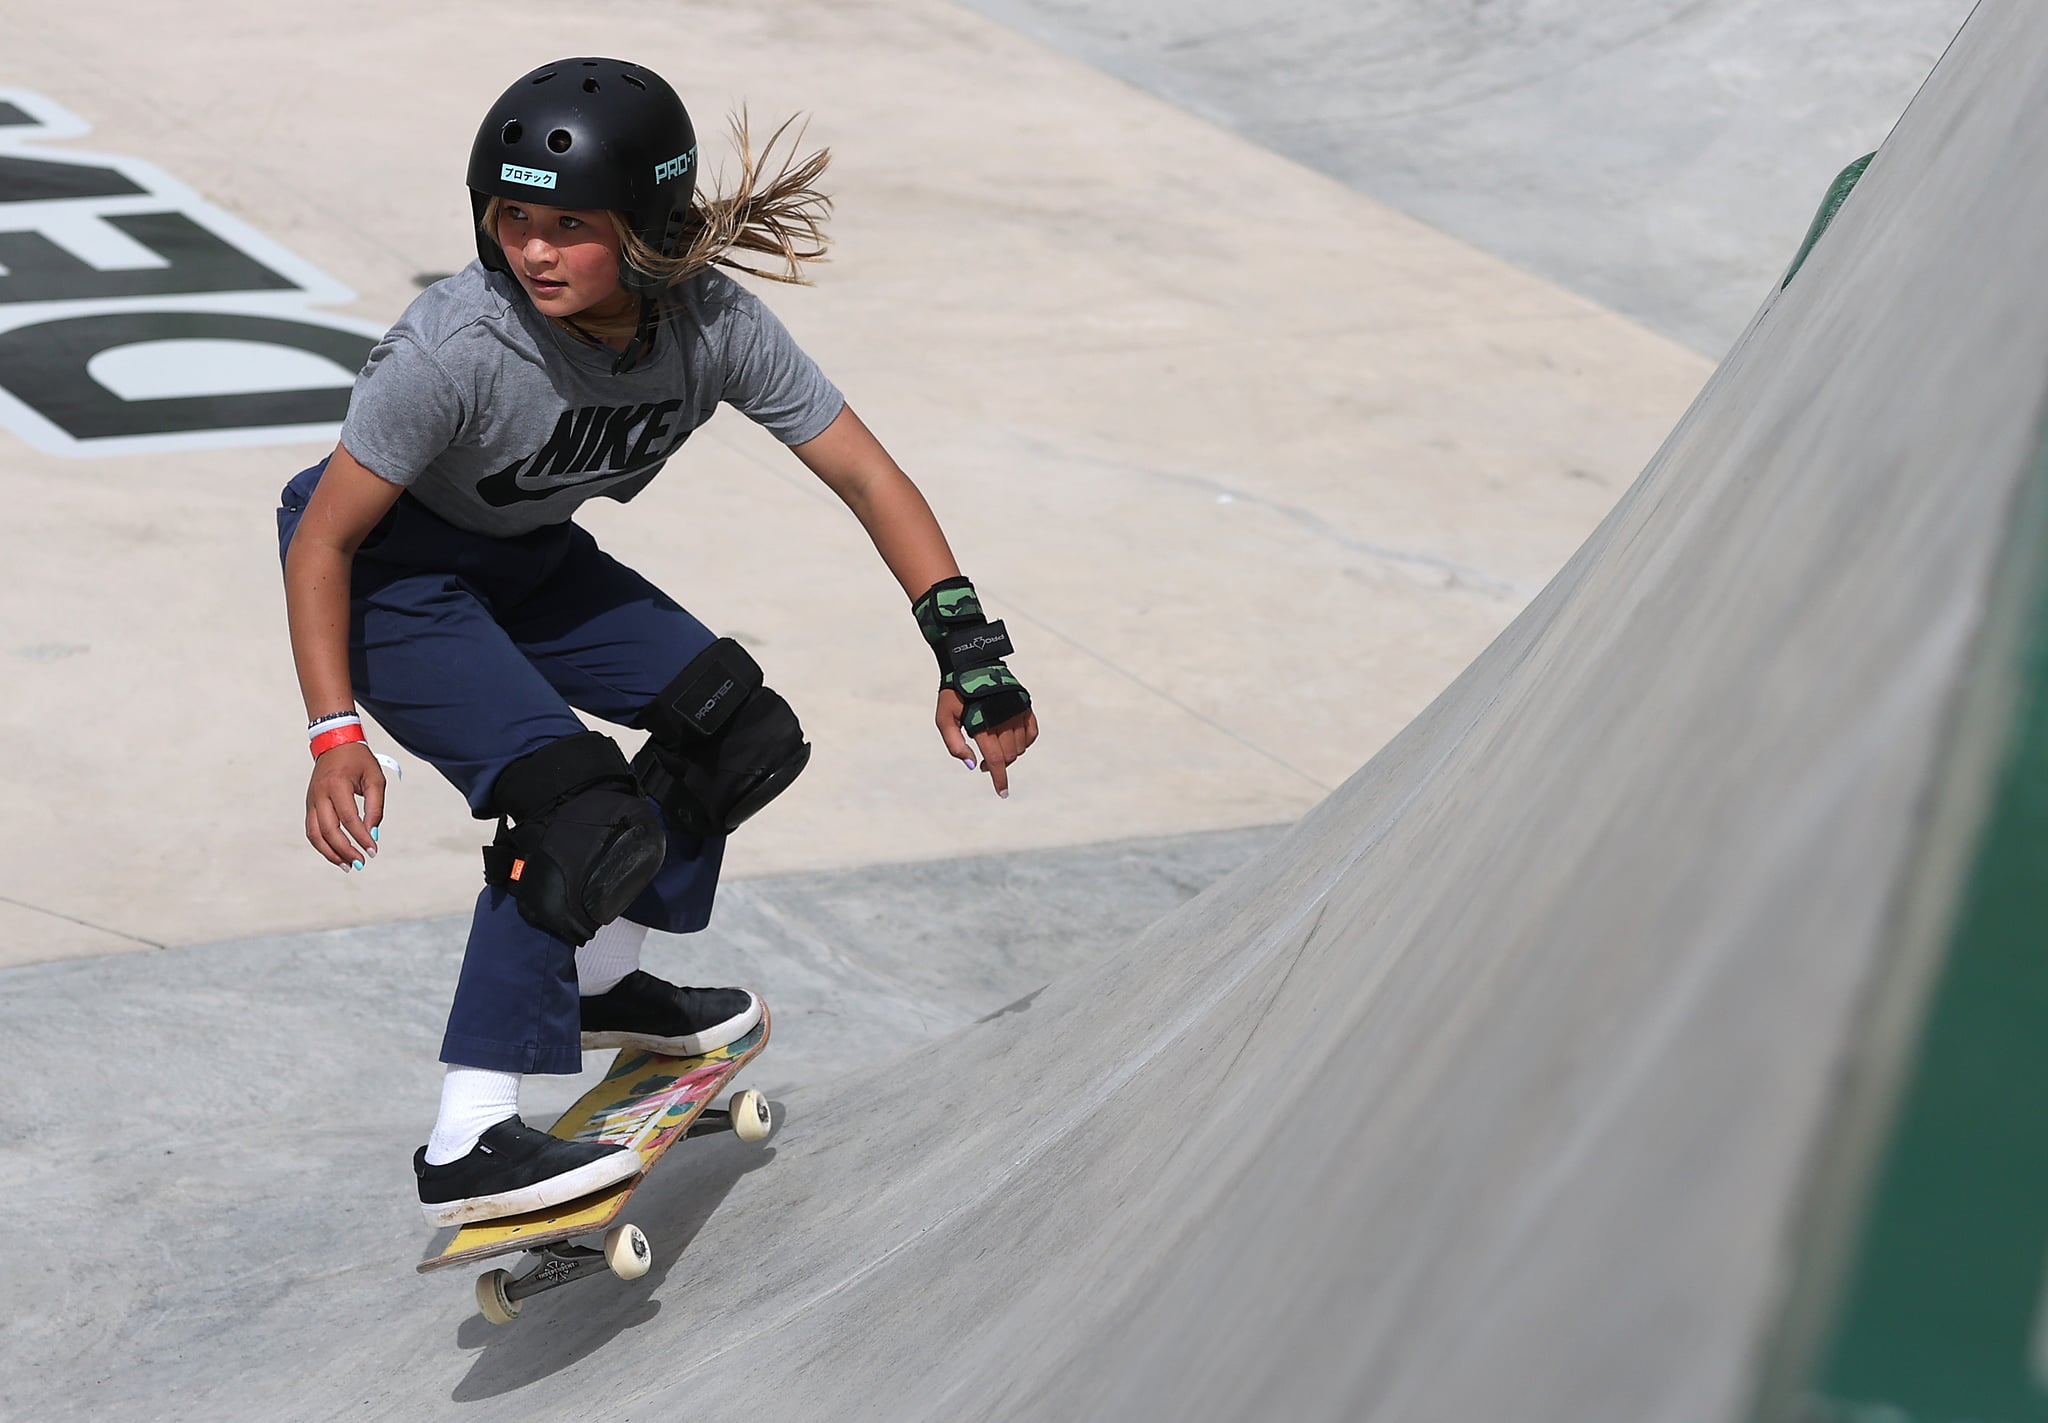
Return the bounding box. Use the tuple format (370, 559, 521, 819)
(276, 461, 725, 1073)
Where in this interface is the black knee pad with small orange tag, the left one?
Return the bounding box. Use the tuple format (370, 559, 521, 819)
(483, 731, 668, 948)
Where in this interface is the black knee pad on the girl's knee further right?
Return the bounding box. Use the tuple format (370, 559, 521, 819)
(633, 637, 811, 835)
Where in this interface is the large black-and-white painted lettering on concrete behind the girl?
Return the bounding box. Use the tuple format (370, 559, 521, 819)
(0, 90, 381, 455)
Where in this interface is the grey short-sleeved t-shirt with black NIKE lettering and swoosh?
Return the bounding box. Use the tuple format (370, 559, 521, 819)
(342, 262, 846, 536)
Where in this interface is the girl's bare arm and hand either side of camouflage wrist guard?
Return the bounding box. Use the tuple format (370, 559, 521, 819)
(795, 405, 1038, 796)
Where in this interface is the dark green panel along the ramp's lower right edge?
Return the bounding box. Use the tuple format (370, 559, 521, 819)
(1810, 454, 2048, 1423)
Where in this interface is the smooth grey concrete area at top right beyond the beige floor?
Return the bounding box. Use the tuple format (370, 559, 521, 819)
(965, 0, 1972, 356)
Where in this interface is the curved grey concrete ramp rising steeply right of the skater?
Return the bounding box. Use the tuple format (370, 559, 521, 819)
(0, 0, 2048, 1423)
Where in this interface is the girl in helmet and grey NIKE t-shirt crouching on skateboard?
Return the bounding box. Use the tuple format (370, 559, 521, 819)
(279, 59, 1038, 1224)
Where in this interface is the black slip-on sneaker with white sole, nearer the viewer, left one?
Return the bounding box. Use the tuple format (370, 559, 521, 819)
(412, 1116, 641, 1224)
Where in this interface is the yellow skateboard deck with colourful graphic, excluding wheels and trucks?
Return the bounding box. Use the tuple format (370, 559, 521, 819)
(418, 1003, 768, 1274)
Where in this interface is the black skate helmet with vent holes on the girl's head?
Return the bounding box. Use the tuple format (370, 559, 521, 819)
(469, 59, 696, 291)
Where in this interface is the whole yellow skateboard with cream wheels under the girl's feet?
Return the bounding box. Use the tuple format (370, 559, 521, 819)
(420, 1003, 774, 1325)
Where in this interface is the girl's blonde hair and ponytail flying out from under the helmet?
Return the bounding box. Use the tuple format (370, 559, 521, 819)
(479, 109, 831, 287)
